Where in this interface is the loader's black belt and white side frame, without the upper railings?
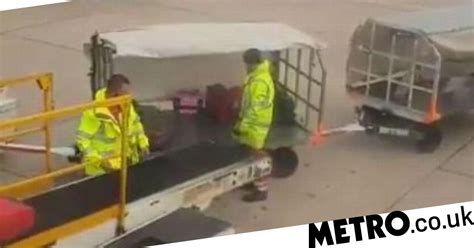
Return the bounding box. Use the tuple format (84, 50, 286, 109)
(0, 144, 271, 247)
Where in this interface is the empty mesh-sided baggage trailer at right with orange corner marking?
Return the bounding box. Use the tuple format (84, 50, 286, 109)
(346, 4, 474, 152)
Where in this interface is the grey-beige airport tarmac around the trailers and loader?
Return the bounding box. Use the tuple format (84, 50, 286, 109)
(0, 0, 474, 240)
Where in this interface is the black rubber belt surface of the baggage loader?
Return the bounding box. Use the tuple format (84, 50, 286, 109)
(5, 144, 249, 245)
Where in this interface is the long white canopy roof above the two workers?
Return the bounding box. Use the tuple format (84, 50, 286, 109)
(100, 23, 326, 58)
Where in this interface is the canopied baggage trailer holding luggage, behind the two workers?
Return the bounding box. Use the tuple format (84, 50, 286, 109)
(85, 22, 326, 148)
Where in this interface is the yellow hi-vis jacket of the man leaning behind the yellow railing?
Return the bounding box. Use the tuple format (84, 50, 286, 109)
(76, 89, 149, 176)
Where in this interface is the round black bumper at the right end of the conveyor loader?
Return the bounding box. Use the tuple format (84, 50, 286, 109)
(269, 147, 299, 178)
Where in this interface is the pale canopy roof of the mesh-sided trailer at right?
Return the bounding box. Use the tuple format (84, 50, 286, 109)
(373, 2, 474, 59)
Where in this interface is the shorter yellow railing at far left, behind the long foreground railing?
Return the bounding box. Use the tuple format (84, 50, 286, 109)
(0, 73, 54, 172)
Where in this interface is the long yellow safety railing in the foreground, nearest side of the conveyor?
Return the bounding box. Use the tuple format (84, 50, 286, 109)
(0, 95, 132, 247)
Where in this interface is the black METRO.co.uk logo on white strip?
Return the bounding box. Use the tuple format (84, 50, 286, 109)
(309, 206, 474, 248)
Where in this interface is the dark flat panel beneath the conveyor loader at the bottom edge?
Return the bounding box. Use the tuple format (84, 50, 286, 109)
(104, 209, 232, 248)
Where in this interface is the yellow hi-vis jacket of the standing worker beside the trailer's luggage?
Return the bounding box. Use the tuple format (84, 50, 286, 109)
(233, 60, 275, 149)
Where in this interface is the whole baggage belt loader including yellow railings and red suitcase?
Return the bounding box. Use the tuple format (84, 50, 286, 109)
(0, 96, 272, 247)
